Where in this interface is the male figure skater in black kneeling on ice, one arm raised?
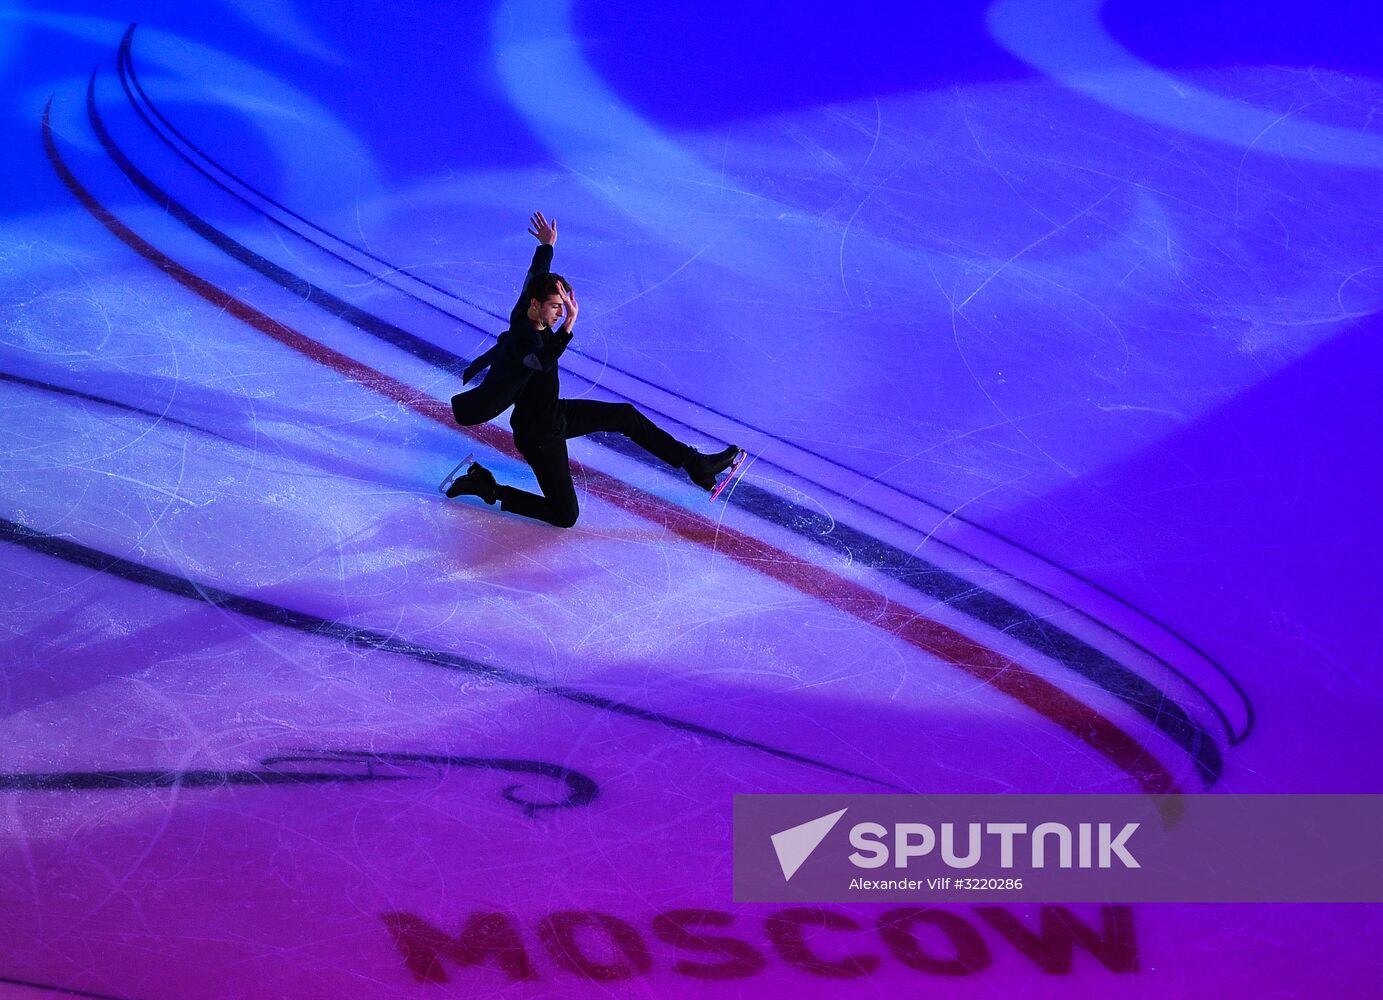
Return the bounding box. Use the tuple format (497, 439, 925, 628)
(447, 212, 740, 528)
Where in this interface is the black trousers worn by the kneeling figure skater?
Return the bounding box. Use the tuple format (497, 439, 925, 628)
(499, 400, 690, 528)
